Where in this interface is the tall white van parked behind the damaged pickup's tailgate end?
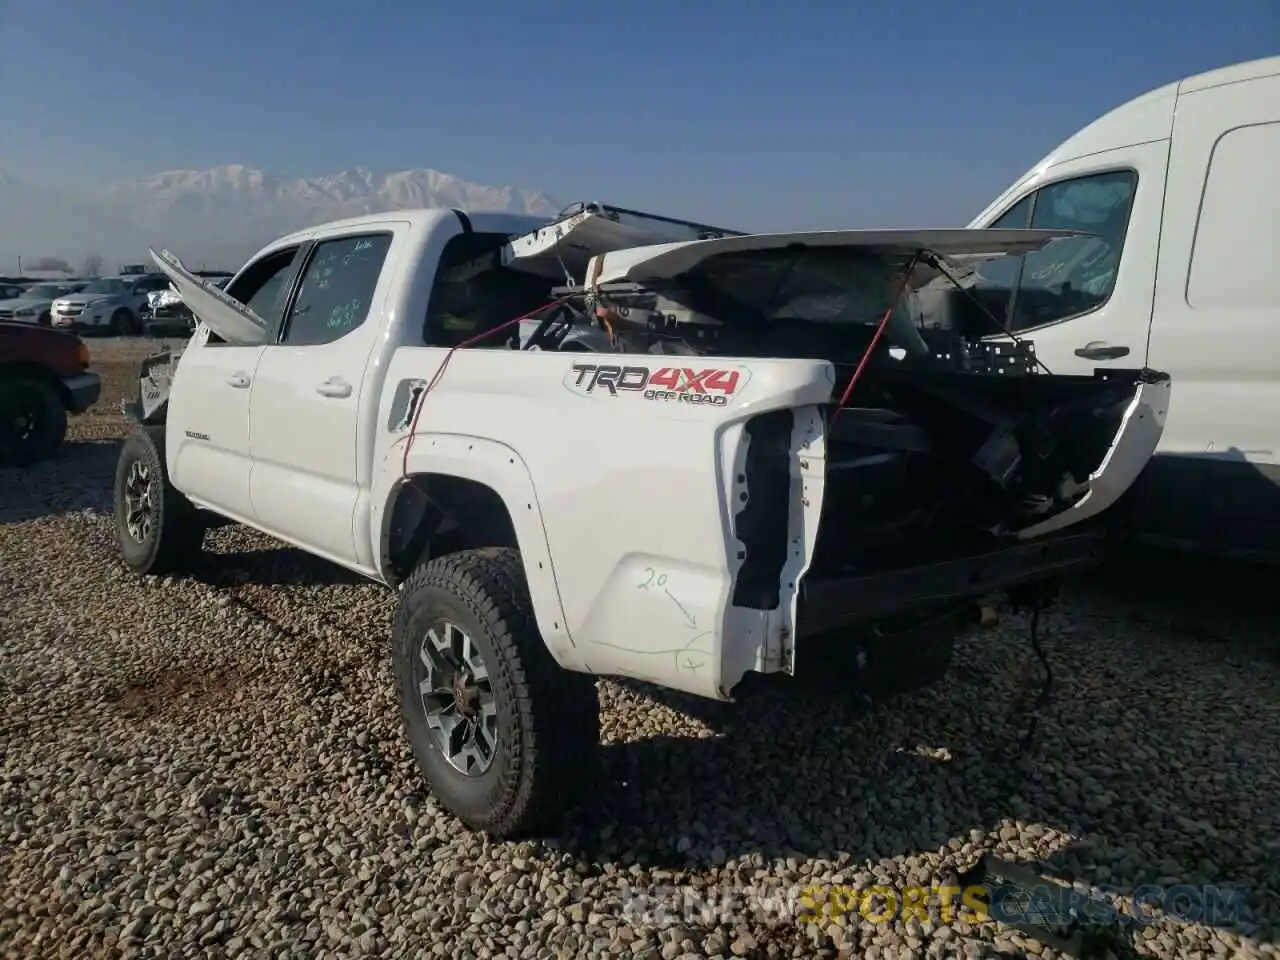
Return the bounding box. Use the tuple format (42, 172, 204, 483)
(946, 56, 1280, 558)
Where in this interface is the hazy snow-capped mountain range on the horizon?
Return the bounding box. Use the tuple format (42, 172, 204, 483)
(0, 164, 561, 274)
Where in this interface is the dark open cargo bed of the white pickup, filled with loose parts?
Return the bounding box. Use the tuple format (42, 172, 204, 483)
(491, 238, 1161, 575)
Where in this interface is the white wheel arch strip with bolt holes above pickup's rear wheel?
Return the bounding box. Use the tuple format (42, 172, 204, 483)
(374, 433, 582, 669)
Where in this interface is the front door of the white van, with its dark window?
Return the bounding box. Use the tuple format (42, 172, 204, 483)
(974, 141, 1169, 374)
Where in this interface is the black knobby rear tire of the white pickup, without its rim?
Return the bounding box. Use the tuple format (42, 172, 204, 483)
(392, 548, 600, 838)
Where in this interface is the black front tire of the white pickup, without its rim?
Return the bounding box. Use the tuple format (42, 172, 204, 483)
(114, 426, 206, 576)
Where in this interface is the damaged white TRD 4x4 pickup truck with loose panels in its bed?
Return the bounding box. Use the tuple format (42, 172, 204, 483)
(115, 204, 1170, 836)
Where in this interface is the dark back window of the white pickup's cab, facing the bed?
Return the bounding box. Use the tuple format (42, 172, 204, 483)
(422, 233, 556, 349)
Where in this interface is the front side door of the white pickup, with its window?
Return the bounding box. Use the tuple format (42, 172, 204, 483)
(166, 243, 303, 522)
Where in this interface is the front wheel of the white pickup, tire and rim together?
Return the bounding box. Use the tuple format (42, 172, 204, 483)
(115, 426, 205, 575)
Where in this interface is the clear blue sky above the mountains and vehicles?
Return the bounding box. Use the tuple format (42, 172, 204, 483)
(0, 0, 1280, 230)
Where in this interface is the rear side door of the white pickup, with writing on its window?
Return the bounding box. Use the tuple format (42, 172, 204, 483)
(250, 220, 410, 568)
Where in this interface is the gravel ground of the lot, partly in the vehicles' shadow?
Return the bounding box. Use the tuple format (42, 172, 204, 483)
(0, 340, 1280, 960)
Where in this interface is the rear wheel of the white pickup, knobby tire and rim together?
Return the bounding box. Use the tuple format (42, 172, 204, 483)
(392, 548, 600, 838)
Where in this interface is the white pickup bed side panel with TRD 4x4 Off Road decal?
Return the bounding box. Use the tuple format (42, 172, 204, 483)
(371, 347, 832, 698)
